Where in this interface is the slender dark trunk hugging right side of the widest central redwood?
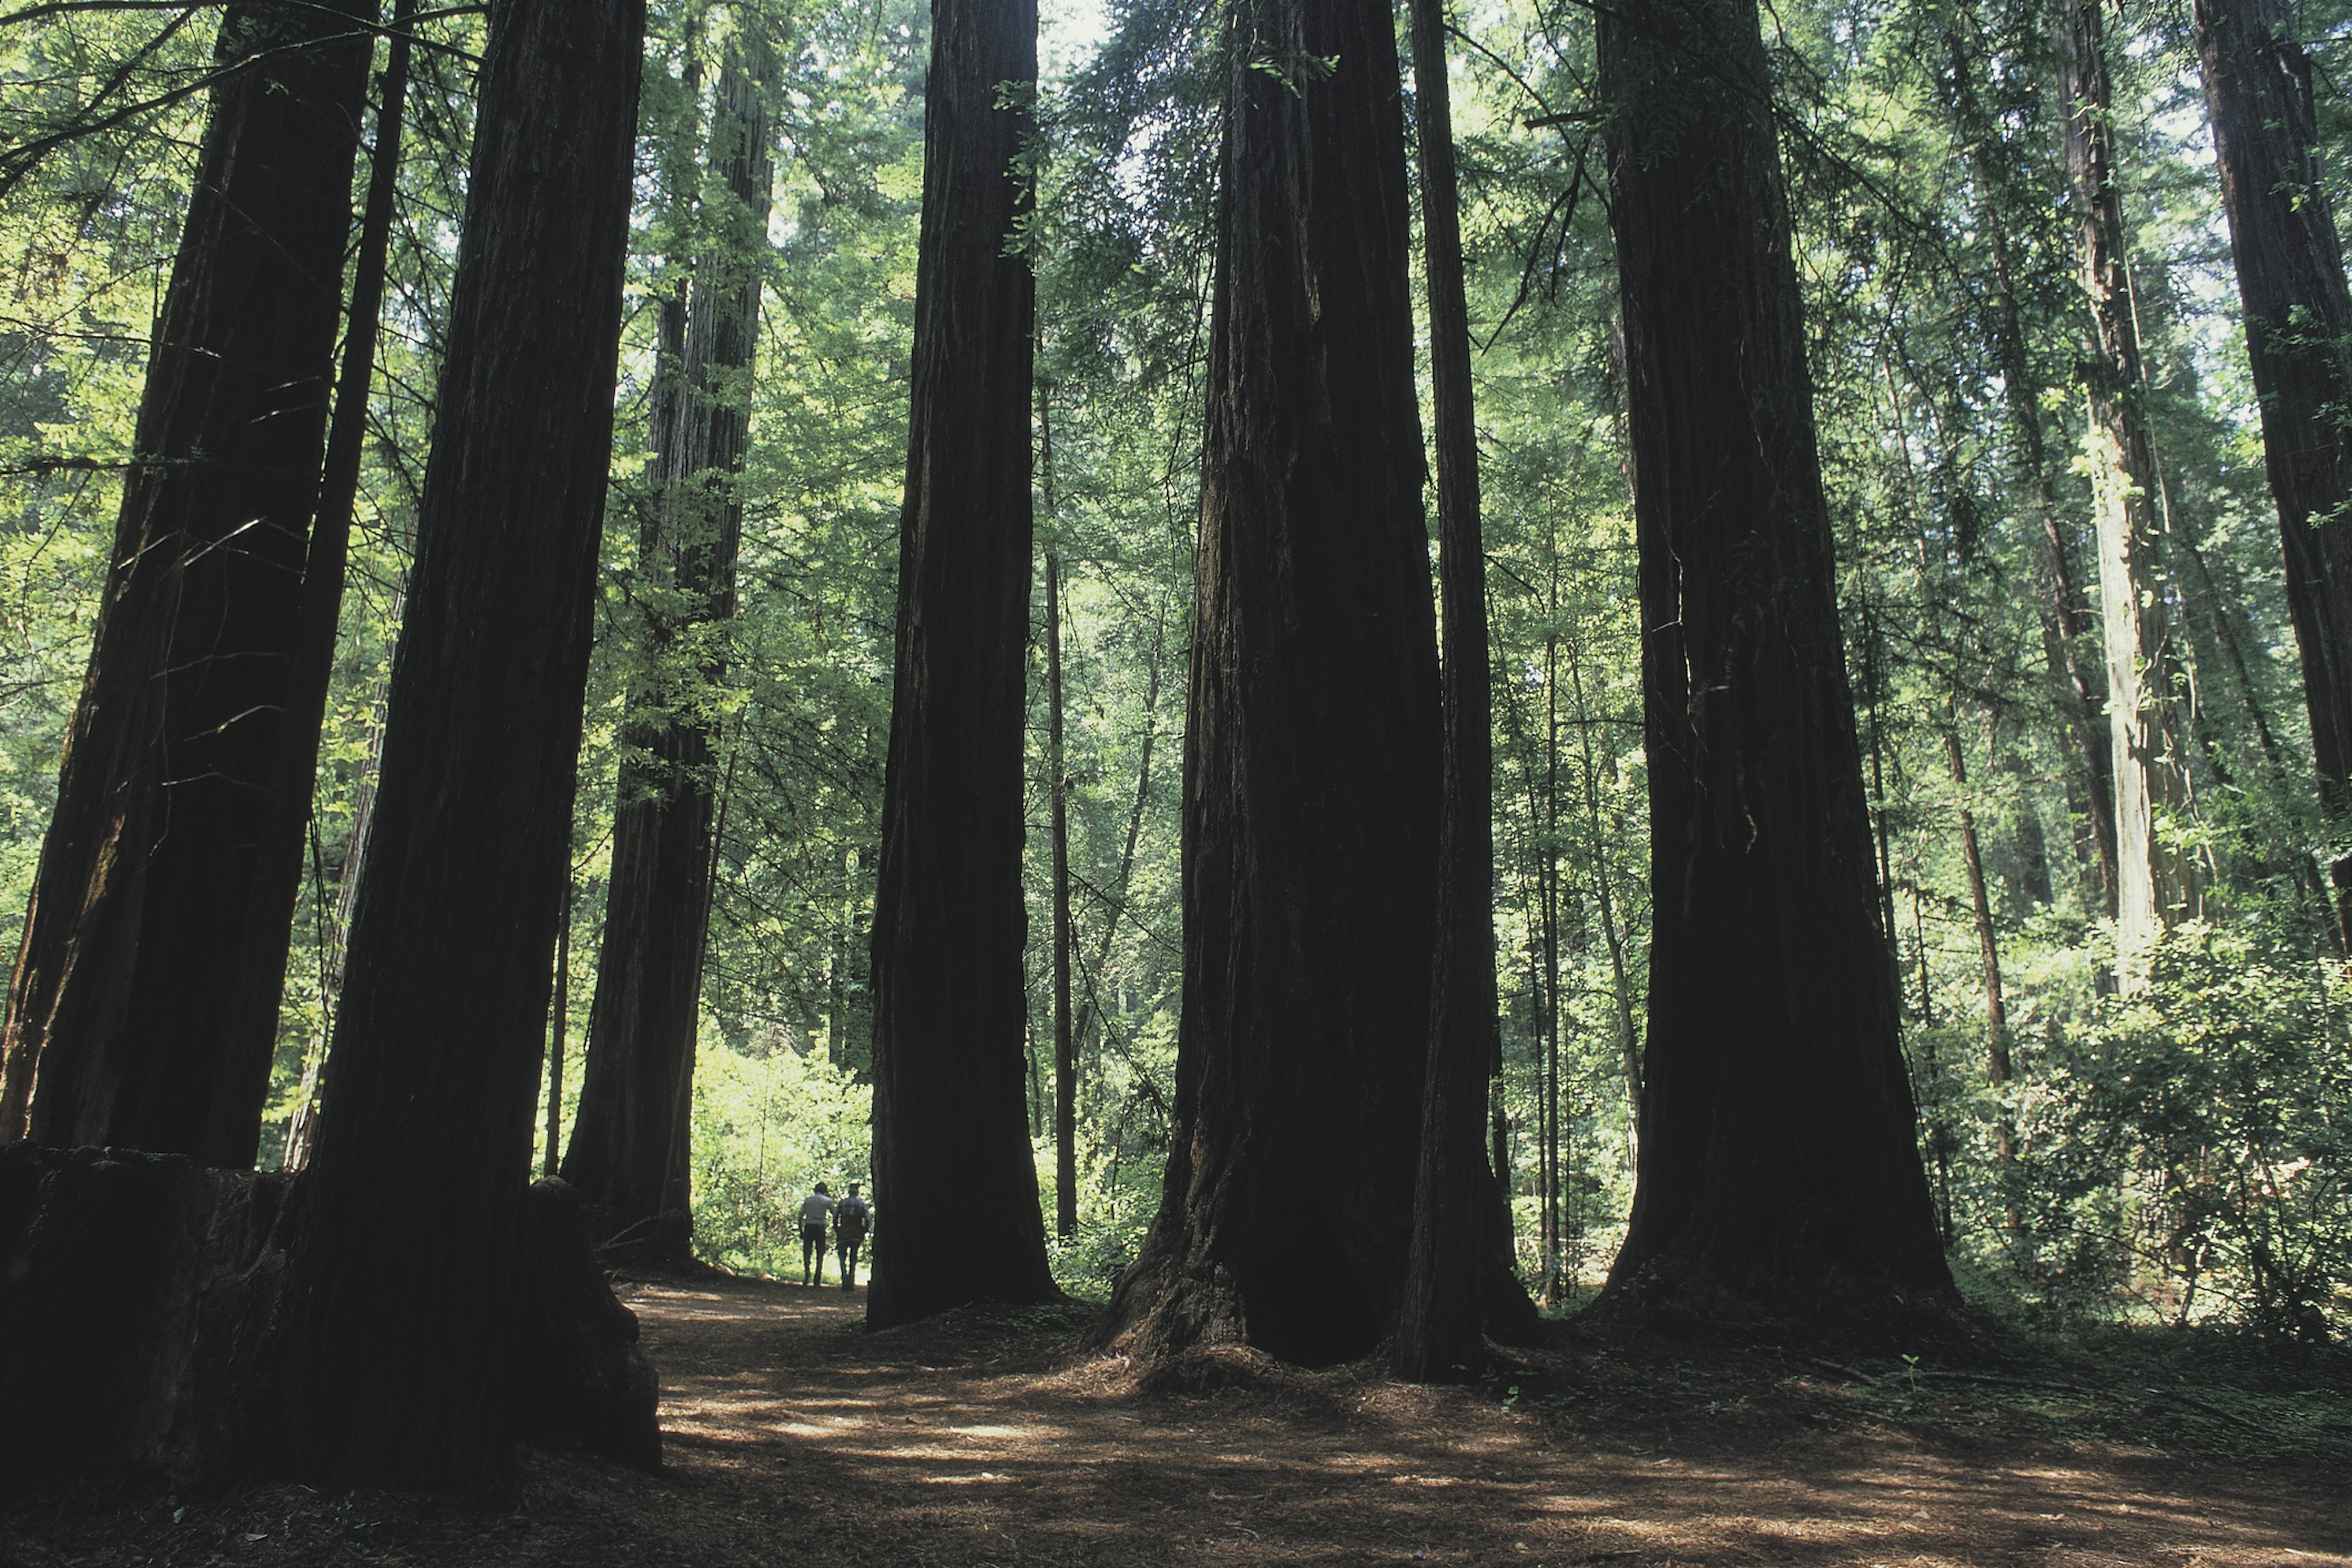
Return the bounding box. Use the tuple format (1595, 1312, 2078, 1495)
(1392, 0, 1536, 1382)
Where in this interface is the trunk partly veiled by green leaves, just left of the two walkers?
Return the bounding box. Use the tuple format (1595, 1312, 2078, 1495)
(562, 40, 774, 1270)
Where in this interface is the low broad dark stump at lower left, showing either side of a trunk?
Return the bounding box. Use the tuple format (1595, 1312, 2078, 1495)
(0, 1142, 661, 1490)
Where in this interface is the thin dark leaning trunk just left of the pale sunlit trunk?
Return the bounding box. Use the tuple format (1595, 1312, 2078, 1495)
(1948, 12, 2122, 914)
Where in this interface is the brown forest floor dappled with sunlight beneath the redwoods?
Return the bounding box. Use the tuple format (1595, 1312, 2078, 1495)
(0, 1281, 2352, 1568)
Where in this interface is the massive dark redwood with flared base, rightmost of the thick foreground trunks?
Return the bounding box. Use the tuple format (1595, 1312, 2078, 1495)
(1599, 0, 1950, 1310)
